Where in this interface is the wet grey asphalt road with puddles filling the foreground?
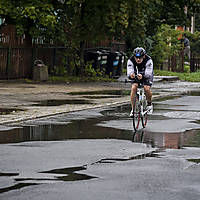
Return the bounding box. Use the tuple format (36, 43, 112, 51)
(0, 85, 200, 200)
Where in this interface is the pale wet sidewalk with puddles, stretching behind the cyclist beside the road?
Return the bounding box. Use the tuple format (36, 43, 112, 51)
(0, 77, 200, 125)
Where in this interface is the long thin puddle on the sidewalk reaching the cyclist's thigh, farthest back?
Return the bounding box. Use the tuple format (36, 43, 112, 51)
(69, 90, 130, 96)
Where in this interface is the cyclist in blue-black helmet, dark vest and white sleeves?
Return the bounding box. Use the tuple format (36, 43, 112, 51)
(127, 47, 153, 117)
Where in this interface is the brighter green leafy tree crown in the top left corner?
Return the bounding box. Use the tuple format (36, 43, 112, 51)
(0, 0, 56, 41)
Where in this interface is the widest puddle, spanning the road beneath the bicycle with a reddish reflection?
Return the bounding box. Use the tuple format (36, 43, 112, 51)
(0, 107, 200, 149)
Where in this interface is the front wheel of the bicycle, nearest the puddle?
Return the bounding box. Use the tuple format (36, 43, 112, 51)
(133, 95, 141, 131)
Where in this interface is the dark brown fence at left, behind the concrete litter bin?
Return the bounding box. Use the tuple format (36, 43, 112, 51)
(0, 47, 67, 79)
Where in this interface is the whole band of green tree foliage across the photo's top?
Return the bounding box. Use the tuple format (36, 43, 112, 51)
(0, 0, 200, 76)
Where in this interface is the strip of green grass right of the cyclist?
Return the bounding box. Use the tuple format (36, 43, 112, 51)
(154, 70, 200, 82)
